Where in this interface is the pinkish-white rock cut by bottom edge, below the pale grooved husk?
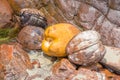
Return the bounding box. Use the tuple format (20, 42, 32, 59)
(68, 68, 106, 80)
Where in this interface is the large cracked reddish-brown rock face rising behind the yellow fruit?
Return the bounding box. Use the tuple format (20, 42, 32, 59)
(9, 0, 120, 47)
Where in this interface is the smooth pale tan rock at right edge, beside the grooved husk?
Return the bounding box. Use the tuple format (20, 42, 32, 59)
(100, 46, 120, 74)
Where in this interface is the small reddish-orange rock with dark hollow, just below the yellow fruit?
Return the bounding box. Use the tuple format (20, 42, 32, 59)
(52, 59, 75, 78)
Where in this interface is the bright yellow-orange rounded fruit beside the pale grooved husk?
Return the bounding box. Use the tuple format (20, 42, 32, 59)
(42, 23, 80, 57)
